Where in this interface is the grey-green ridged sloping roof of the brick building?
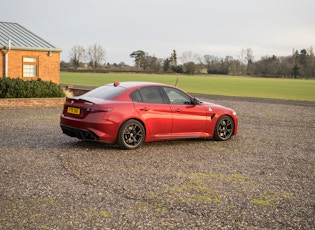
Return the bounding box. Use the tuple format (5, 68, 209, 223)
(0, 22, 61, 52)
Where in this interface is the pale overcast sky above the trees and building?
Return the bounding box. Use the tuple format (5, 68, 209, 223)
(0, 0, 315, 64)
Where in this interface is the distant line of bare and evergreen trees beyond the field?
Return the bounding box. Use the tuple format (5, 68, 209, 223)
(60, 44, 315, 78)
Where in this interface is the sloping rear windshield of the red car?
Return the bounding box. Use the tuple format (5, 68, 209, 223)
(84, 85, 126, 100)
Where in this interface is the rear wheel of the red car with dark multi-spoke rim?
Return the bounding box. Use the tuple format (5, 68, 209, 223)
(117, 119, 145, 150)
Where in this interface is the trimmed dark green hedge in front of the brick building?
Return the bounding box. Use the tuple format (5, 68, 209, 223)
(0, 78, 65, 98)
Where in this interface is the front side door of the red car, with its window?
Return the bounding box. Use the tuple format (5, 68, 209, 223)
(163, 87, 209, 137)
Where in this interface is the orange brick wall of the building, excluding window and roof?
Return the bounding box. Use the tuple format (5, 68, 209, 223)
(0, 50, 60, 84)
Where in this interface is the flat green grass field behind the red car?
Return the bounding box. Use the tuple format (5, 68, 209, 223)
(60, 72, 315, 101)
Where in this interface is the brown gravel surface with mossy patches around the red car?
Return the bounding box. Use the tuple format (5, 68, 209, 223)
(0, 98, 315, 229)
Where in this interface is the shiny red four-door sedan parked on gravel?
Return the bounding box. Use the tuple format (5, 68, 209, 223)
(60, 82, 238, 149)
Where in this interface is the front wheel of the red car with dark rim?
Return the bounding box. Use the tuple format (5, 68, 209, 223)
(214, 116, 234, 141)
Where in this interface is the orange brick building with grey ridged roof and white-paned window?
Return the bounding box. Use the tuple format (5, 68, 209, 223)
(0, 22, 61, 84)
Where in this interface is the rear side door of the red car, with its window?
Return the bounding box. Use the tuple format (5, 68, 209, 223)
(131, 86, 172, 140)
